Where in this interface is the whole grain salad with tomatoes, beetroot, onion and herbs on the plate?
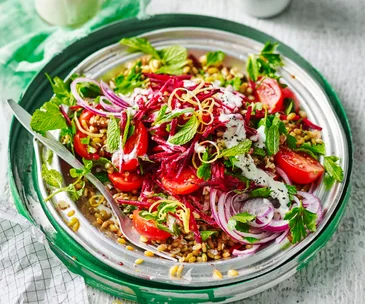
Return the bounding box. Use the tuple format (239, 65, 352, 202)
(31, 37, 343, 263)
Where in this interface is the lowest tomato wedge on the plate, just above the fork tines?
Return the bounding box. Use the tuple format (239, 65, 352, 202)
(133, 209, 171, 241)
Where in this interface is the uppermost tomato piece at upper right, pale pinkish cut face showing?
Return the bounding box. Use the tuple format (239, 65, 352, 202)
(256, 77, 284, 113)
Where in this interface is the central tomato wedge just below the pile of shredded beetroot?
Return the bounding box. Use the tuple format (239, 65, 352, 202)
(161, 168, 202, 194)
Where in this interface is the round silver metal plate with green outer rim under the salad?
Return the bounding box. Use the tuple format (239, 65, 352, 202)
(9, 15, 352, 302)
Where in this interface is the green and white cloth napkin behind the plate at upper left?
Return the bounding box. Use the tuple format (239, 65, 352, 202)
(0, 0, 149, 100)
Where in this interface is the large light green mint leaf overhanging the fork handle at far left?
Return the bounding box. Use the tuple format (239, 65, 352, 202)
(30, 101, 67, 135)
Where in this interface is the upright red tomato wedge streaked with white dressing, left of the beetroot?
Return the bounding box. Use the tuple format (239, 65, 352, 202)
(119, 121, 148, 171)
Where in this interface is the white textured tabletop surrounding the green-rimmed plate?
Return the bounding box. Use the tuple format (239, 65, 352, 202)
(89, 0, 365, 304)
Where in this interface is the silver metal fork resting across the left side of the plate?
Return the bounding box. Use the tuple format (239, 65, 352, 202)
(7, 99, 177, 261)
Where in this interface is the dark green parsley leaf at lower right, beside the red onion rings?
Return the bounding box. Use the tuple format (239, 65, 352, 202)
(284, 206, 317, 244)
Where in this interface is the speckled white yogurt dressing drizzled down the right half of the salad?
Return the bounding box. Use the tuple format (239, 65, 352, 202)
(219, 114, 289, 217)
